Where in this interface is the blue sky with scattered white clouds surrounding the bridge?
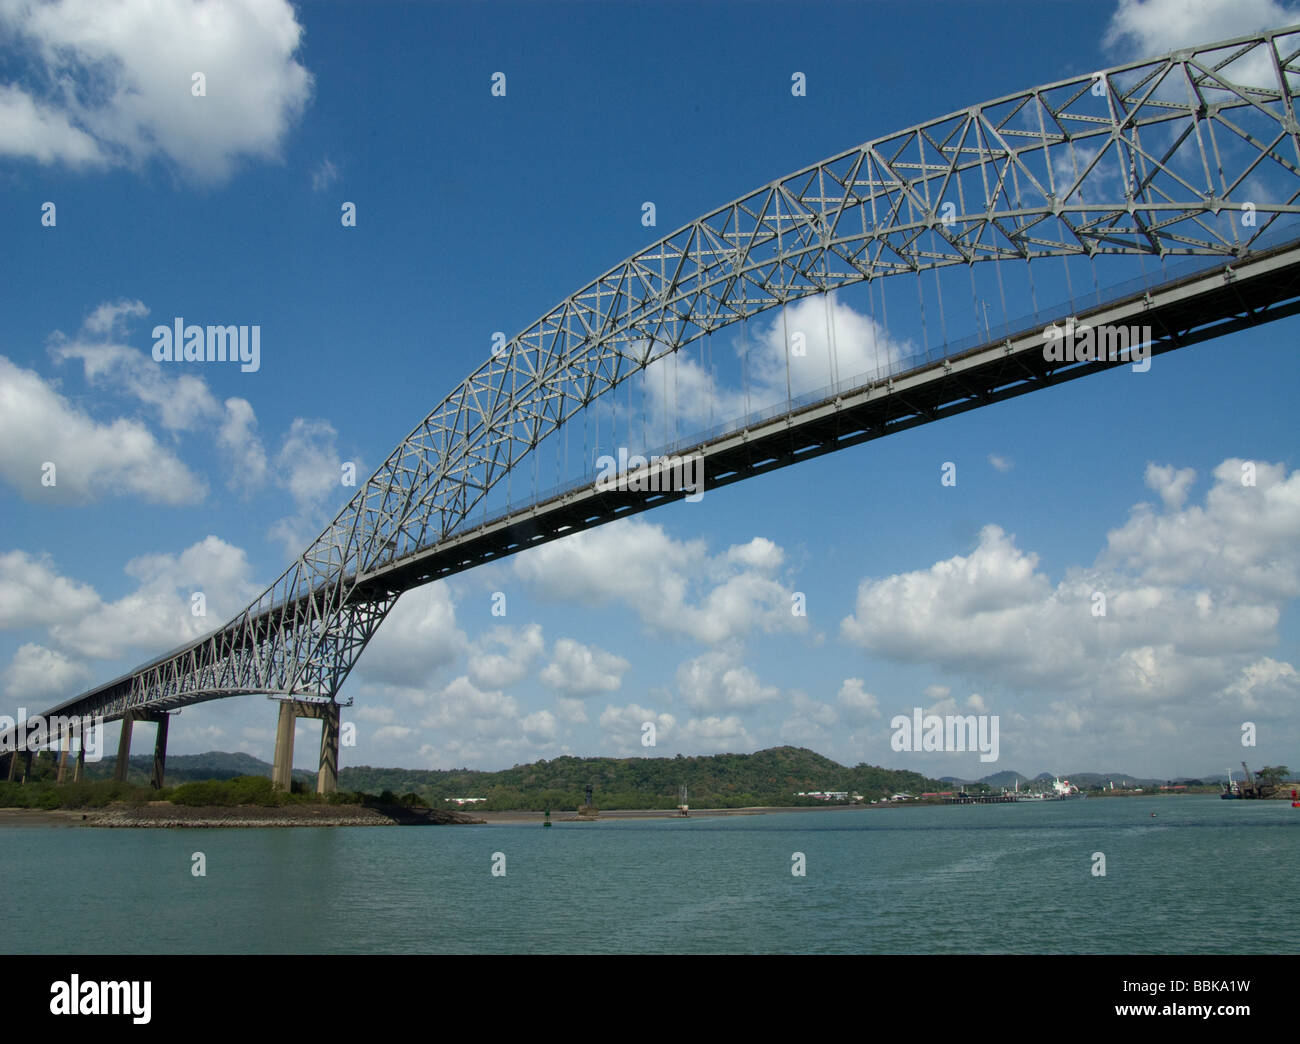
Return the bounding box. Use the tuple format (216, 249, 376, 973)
(0, 0, 1300, 776)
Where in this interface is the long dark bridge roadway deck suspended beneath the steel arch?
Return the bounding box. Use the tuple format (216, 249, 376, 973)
(10, 239, 1300, 785)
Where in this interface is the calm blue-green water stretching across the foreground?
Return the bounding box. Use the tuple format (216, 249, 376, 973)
(0, 797, 1300, 953)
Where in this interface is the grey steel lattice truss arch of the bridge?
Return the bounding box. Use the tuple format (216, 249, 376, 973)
(7, 26, 1300, 769)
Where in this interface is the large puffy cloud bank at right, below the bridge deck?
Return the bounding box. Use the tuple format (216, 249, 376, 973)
(841, 459, 1300, 709)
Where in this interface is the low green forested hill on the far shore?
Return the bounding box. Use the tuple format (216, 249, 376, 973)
(338, 746, 945, 810)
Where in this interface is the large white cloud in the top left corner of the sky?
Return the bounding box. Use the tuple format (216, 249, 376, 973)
(0, 0, 312, 183)
